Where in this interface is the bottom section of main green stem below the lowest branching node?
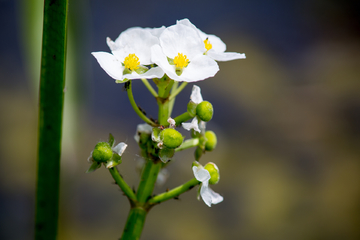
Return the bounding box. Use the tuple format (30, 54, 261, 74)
(121, 206, 147, 240)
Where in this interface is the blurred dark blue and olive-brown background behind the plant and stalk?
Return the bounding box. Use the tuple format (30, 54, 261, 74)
(0, 0, 360, 240)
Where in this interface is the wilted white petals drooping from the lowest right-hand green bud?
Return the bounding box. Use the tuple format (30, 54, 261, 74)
(192, 166, 224, 207)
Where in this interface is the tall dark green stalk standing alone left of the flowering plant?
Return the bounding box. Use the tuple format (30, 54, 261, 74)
(35, 0, 68, 240)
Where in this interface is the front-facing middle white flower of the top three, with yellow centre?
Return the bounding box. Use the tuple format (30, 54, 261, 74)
(151, 24, 219, 82)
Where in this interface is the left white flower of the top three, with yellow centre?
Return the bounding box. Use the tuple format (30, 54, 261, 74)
(91, 27, 164, 81)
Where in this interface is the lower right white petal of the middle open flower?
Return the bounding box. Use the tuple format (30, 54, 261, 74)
(179, 54, 219, 82)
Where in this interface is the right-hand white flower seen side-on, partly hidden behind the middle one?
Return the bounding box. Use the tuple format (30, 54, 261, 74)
(177, 18, 246, 61)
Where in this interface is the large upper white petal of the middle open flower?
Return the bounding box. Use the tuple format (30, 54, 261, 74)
(159, 24, 206, 61)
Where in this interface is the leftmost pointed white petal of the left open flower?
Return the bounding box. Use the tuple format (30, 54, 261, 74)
(91, 52, 124, 80)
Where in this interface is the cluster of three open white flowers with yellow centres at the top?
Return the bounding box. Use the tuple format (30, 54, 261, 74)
(92, 19, 245, 82)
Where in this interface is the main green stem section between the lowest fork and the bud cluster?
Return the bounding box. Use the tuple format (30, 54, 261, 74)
(137, 159, 162, 203)
